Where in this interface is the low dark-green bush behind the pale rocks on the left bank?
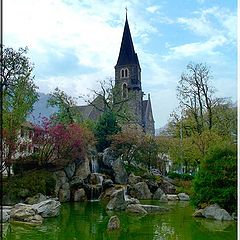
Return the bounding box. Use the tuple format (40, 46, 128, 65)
(3, 170, 56, 202)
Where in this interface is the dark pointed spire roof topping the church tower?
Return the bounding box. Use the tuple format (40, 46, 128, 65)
(116, 11, 139, 66)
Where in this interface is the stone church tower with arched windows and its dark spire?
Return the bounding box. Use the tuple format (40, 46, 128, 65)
(115, 13, 144, 127)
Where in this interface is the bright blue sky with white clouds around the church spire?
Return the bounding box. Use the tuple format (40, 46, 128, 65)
(3, 0, 237, 128)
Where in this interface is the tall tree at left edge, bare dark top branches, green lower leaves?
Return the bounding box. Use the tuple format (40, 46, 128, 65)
(1, 48, 38, 175)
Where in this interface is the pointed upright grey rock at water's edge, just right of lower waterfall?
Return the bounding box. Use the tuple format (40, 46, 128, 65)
(106, 189, 127, 210)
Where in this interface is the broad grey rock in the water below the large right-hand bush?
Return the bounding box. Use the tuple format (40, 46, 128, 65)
(202, 204, 233, 221)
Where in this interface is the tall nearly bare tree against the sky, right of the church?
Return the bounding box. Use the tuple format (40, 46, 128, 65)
(177, 63, 215, 134)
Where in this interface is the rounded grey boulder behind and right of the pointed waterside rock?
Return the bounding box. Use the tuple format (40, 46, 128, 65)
(129, 182, 152, 199)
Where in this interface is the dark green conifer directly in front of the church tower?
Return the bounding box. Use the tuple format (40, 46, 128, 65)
(94, 111, 120, 152)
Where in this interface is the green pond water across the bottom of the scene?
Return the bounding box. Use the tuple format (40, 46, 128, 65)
(4, 201, 237, 240)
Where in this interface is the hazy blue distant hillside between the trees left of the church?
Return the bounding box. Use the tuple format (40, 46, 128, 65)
(28, 93, 57, 122)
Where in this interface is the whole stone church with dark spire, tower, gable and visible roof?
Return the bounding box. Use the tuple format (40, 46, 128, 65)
(78, 13, 155, 135)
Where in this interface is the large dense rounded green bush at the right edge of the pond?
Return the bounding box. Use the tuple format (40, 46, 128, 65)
(192, 142, 237, 212)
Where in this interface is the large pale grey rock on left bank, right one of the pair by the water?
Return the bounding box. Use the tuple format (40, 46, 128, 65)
(32, 199, 61, 218)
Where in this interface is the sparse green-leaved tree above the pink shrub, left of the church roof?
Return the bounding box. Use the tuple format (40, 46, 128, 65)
(48, 88, 81, 124)
